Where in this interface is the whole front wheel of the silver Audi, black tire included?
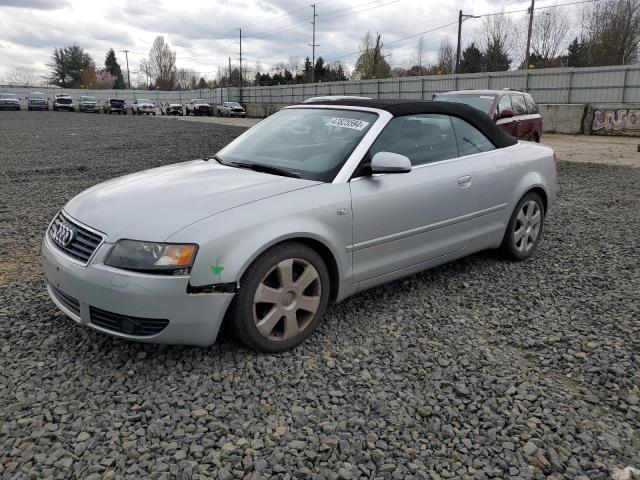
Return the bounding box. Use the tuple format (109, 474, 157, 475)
(228, 242, 330, 353)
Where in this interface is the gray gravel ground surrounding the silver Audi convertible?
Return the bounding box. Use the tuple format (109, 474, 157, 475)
(0, 112, 640, 479)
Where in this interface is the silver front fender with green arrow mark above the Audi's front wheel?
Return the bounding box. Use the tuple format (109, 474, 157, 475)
(168, 183, 352, 286)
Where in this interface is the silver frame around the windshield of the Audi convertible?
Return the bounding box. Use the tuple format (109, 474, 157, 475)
(216, 104, 393, 183)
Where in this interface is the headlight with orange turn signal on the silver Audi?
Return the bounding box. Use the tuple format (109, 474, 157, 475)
(104, 240, 198, 275)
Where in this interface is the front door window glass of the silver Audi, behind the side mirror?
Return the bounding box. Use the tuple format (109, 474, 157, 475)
(370, 114, 458, 166)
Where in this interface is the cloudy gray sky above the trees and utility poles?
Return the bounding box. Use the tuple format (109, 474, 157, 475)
(0, 0, 576, 81)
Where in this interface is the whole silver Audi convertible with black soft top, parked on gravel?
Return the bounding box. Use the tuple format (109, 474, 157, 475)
(42, 99, 557, 352)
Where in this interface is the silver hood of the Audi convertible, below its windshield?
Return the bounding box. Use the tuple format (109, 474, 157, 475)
(64, 160, 320, 242)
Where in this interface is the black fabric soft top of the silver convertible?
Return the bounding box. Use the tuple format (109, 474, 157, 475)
(306, 99, 518, 148)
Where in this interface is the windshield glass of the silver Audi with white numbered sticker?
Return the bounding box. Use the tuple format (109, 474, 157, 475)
(217, 108, 377, 182)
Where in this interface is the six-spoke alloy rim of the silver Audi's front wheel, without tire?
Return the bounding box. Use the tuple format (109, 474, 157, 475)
(253, 258, 322, 342)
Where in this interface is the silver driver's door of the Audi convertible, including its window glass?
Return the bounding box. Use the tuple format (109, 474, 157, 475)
(350, 114, 475, 283)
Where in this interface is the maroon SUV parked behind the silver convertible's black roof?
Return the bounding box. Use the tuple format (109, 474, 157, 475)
(434, 89, 542, 142)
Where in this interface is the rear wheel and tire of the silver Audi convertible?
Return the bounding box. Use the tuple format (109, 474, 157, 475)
(500, 192, 545, 262)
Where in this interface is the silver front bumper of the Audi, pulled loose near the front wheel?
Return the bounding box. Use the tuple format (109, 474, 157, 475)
(42, 235, 233, 346)
